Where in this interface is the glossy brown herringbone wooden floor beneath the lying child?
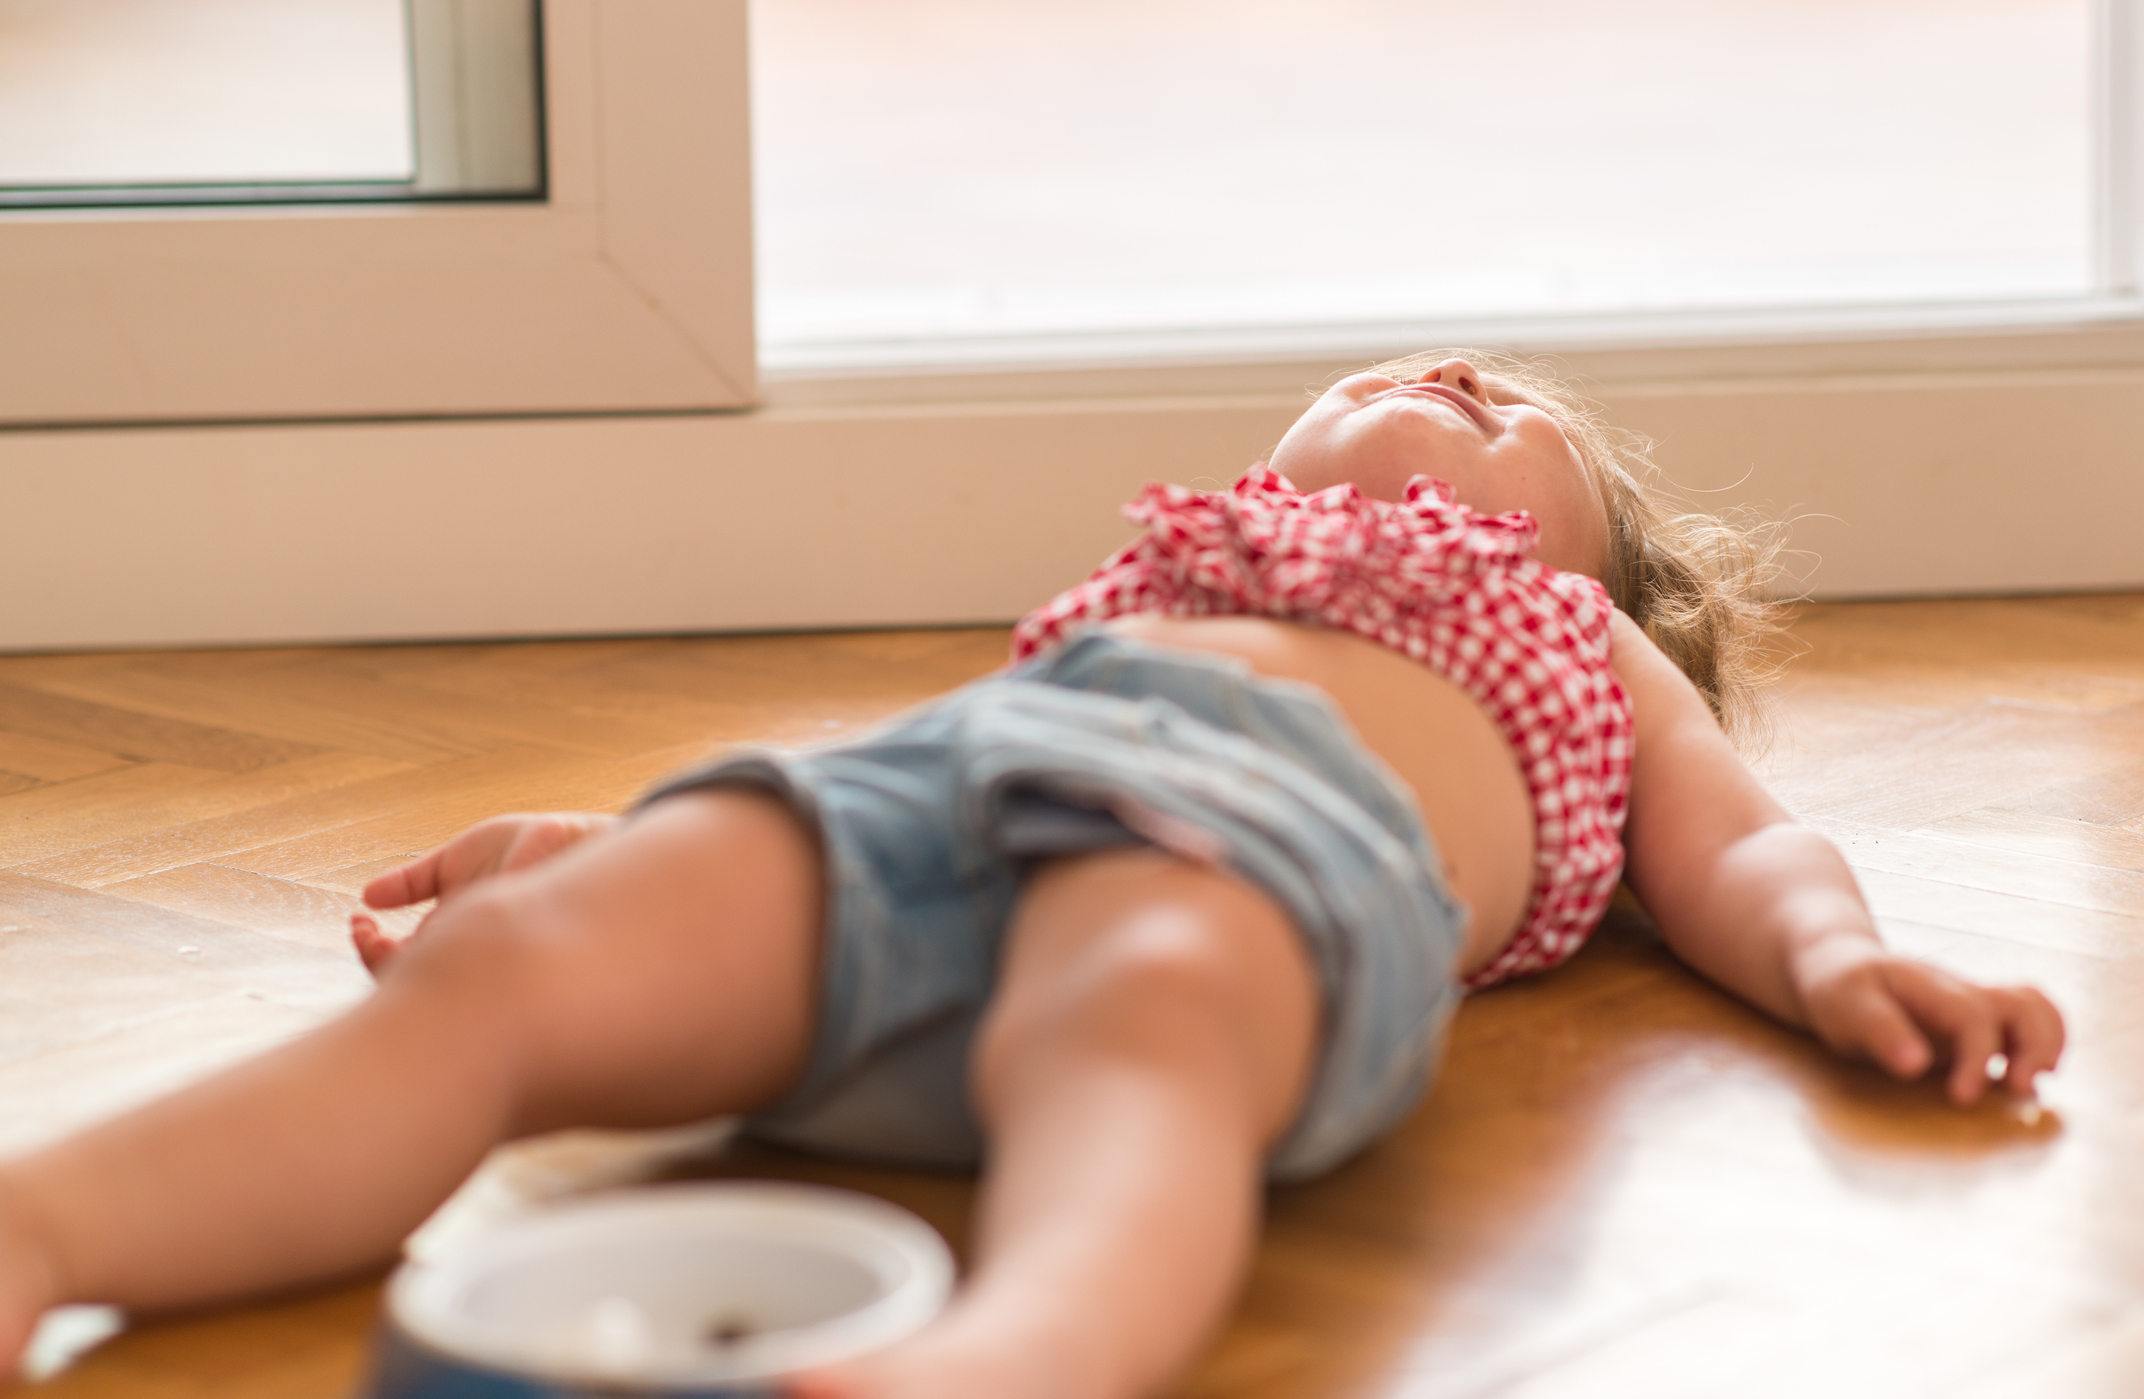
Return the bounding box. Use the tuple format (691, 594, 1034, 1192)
(0, 596, 2144, 1399)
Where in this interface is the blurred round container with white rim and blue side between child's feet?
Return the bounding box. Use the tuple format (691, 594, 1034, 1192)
(362, 1183, 954, 1399)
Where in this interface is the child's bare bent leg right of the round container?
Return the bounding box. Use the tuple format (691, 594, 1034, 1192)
(795, 851, 1316, 1399)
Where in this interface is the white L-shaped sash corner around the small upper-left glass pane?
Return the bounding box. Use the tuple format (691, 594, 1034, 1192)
(0, 0, 757, 426)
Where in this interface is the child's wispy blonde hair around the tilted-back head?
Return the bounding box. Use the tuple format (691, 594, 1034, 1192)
(1374, 349, 1782, 746)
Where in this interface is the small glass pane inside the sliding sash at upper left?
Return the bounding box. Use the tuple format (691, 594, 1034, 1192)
(0, 0, 542, 206)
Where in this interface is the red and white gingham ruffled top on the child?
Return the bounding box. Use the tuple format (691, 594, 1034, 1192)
(1012, 463, 1632, 990)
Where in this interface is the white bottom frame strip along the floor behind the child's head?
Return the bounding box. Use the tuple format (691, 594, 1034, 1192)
(0, 368, 2144, 651)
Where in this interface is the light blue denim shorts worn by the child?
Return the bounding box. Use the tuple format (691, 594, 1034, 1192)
(643, 632, 1466, 1180)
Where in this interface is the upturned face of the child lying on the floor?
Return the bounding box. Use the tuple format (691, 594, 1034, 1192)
(1269, 358, 1608, 578)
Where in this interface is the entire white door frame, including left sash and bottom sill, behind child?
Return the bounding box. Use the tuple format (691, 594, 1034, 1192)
(0, 0, 2144, 649)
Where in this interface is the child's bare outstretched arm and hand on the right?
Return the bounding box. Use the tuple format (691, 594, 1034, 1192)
(1614, 613, 2063, 1105)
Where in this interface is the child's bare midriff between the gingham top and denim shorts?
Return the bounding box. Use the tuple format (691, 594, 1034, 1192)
(1106, 613, 1533, 973)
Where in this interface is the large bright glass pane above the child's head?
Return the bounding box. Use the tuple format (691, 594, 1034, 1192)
(753, 0, 2090, 358)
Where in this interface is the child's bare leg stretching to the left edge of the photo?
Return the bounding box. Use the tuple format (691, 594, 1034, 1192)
(0, 793, 821, 1375)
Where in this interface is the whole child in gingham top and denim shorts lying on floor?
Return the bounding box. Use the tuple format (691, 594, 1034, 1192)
(0, 356, 2063, 1399)
